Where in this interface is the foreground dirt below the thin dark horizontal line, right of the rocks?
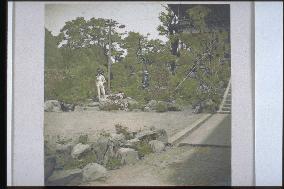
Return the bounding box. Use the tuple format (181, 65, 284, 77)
(81, 146, 231, 186)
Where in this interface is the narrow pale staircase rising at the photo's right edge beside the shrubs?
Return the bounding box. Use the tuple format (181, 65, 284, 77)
(217, 79, 232, 114)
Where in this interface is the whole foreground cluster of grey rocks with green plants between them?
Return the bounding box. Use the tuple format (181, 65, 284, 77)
(45, 125, 168, 185)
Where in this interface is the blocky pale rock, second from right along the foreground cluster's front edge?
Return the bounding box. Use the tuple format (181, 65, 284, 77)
(117, 148, 139, 164)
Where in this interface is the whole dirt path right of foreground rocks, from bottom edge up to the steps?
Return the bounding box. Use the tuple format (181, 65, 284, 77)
(79, 115, 231, 186)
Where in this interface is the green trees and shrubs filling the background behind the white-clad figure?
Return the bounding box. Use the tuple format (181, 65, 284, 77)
(44, 5, 230, 111)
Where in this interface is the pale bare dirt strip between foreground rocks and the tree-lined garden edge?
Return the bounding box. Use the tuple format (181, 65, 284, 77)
(44, 109, 204, 138)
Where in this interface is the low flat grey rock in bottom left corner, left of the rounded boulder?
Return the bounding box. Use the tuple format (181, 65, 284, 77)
(46, 169, 83, 186)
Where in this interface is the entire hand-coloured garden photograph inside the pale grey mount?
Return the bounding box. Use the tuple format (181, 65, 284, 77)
(44, 1, 232, 186)
